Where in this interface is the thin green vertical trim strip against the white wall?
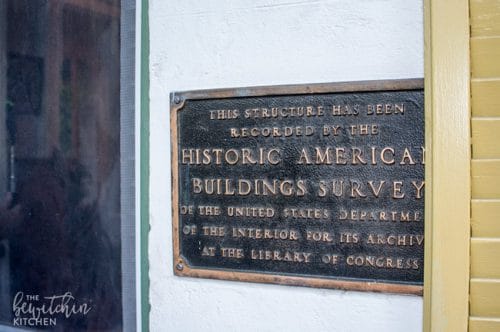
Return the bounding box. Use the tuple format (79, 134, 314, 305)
(138, 0, 151, 332)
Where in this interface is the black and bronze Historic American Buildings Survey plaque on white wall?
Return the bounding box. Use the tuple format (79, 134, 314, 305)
(170, 79, 425, 294)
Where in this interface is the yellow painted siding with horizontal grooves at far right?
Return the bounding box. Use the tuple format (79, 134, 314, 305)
(469, 0, 500, 332)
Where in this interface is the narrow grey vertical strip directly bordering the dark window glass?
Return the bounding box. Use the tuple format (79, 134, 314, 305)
(119, 0, 140, 332)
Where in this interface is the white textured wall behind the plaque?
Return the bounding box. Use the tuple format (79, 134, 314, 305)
(149, 0, 423, 332)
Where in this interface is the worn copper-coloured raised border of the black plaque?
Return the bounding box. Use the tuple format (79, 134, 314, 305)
(170, 78, 425, 296)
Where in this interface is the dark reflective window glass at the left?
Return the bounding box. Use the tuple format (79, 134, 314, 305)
(0, 0, 123, 331)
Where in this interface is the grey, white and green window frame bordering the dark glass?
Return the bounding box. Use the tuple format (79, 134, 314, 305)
(0, 0, 149, 332)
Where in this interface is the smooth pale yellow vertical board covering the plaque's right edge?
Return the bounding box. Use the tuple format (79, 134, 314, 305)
(424, 0, 471, 332)
